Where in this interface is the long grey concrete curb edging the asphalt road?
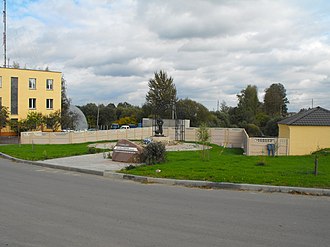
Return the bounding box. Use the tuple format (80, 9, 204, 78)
(0, 152, 330, 196)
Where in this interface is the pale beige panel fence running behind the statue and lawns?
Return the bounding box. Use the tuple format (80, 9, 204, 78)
(21, 127, 289, 155)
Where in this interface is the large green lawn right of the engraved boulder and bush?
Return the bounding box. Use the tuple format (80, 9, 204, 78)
(122, 145, 330, 188)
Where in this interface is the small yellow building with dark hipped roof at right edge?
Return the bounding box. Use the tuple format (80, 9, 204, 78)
(278, 107, 330, 155)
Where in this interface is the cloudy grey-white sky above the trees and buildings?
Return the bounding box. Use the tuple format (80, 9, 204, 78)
(2, 0, 330, 112)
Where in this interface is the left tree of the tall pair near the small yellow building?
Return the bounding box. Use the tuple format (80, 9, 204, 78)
(237, 85, 260, 123)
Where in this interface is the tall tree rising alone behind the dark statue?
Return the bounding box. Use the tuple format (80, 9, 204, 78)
(146, 70, 177, 118)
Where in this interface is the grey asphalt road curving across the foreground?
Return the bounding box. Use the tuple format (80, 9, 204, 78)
(0, 159, 330, 247)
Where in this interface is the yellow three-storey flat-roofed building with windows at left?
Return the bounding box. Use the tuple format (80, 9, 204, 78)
(0, 68, 62, 132)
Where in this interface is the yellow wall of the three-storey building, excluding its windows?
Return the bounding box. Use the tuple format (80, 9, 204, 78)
(0, 68, 62, 133)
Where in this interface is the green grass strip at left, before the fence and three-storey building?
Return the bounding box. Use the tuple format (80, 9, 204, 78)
(0, 143, 104, 160)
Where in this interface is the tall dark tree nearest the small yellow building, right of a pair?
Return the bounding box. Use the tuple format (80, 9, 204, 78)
(264, 83, 289, 117)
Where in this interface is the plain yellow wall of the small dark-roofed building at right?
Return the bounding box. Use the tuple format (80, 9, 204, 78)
(288, 126, 330, 155)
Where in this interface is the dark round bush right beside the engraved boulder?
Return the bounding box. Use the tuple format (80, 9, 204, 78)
(142, 142, 166, 165)
